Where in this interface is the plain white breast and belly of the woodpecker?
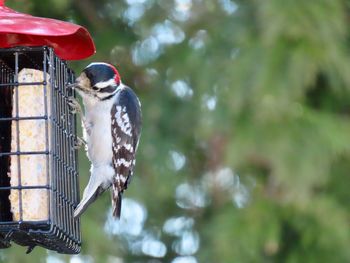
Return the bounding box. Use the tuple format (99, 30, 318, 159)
(84, 96, 113, 166)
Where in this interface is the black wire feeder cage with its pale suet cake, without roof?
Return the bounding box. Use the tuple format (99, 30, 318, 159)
(0, 47, 81, 254)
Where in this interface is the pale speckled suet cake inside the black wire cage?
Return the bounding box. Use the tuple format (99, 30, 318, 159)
(8, 68, 51, 221)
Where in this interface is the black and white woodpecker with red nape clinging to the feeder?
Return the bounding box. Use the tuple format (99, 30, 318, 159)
(70, 62, 141, 218)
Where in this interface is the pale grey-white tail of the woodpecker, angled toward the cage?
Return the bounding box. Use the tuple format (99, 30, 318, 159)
(74, 177, 104, 218)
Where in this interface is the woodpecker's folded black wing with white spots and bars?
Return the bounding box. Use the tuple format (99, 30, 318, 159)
(111, 86, 141, 218)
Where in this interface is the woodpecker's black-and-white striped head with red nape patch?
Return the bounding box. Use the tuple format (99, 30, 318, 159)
(73, 62, 121, 100)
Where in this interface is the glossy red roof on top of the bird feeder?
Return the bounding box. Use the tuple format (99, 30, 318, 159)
(0, 0, 95, 60)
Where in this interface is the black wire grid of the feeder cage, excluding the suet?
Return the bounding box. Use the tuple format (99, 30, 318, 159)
(0, 47, 81, 254)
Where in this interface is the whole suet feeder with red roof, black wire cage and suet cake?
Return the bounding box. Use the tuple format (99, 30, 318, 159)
(0, 0, 95, 254)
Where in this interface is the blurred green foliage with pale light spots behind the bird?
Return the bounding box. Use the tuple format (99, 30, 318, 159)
(0, 0, 350, 263)
